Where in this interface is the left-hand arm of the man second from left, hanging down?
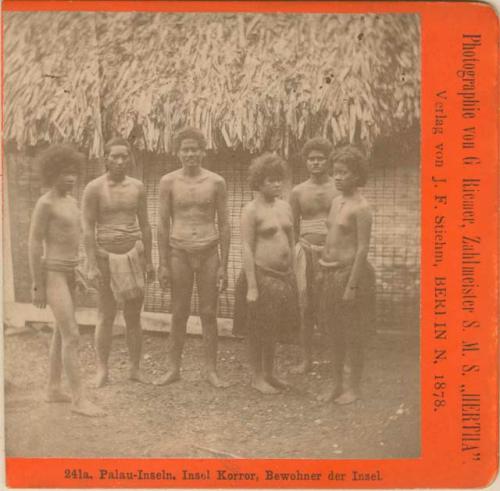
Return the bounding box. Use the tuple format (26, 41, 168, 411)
(82, 183, 100, 282)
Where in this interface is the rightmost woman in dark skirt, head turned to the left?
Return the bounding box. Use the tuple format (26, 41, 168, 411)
(320, 146, 375, 404)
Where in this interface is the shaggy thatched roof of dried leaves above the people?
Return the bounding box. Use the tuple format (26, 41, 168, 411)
(4, 12, 420, 156)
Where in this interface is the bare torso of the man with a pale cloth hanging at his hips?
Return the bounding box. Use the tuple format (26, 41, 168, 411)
(89, 174, 142, 254)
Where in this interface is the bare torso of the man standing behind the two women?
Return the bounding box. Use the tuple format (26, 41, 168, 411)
(291, 177, 339, 245)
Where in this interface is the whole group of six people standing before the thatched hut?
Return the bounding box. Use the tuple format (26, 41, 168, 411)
(29, 127, 375, 416)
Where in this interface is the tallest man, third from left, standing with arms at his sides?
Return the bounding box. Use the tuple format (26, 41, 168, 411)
(156, 128, 230, 387)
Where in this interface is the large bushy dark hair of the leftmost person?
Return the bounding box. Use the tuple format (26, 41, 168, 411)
(37, 144, 85, 186)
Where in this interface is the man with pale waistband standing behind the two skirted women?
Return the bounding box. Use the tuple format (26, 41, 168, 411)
(290, 138, 338, 373)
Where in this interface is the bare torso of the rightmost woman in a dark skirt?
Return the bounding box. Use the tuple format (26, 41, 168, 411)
(323, 195, 369, 264)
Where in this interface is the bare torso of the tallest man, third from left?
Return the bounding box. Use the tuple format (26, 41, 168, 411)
(163, 169, 222, 243)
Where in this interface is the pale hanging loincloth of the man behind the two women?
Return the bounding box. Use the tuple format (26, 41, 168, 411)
(295, 238, 323, 324)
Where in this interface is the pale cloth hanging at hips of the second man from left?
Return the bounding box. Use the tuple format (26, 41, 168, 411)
(97, 240, 146, 303)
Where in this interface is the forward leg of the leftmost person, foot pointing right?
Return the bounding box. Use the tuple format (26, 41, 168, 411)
(46, 271, 102, 416)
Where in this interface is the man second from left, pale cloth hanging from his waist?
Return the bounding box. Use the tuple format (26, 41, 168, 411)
(83, 138, 154, 387)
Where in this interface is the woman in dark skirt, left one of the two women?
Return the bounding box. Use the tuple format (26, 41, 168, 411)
(233, 153, 300, 394)
